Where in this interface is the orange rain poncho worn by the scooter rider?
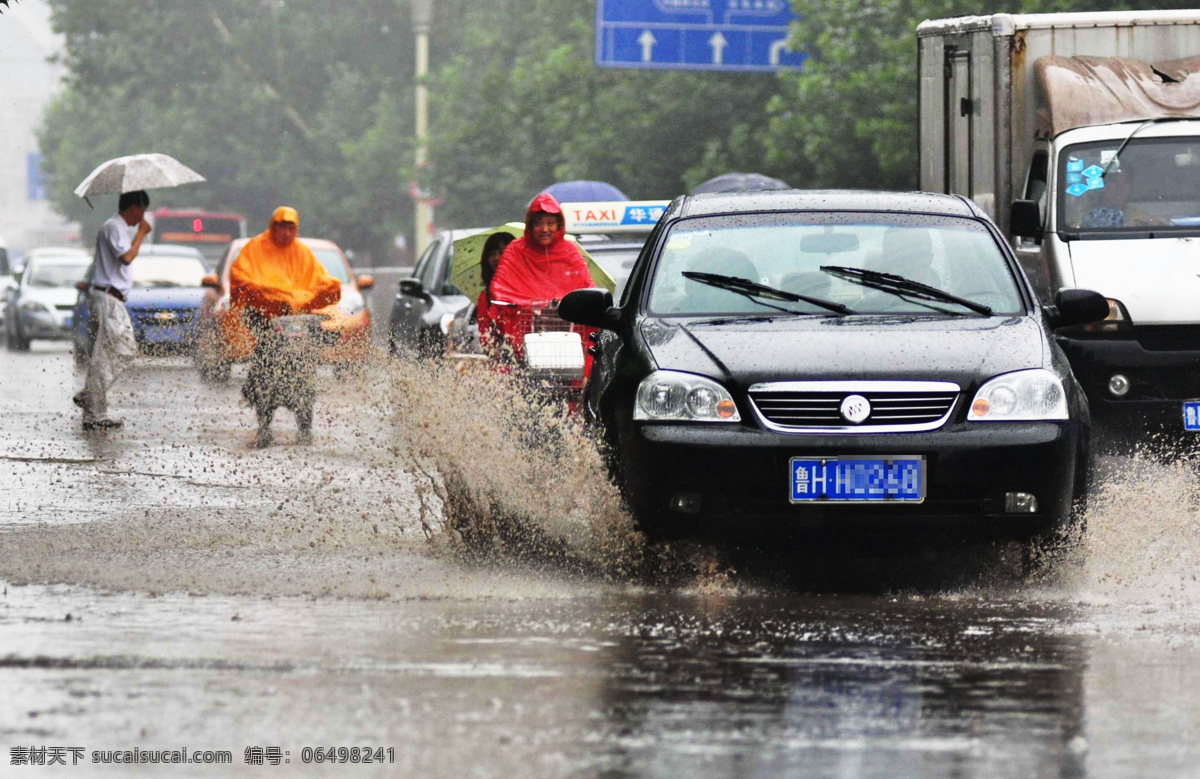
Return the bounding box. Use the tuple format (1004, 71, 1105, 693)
(229, 205, 342, 317)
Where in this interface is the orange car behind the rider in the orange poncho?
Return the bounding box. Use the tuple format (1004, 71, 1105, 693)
(196, 238, 374, 380)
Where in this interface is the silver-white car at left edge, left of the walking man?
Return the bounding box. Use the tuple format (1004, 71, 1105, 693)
(5, 247, 91, 352)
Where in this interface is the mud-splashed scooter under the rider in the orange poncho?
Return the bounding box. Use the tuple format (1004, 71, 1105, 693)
(242, 313, 324, 449)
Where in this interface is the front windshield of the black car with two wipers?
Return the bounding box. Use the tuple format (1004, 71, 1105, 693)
(649, 212, 1025, 316)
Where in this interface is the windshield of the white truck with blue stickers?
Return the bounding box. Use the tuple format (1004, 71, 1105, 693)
(1058, 137, 1200, 238)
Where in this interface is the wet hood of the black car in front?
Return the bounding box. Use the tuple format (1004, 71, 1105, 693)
(641, 316, 1048, 389)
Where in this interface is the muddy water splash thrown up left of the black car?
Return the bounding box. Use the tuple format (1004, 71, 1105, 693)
(394, 360, 644, 577)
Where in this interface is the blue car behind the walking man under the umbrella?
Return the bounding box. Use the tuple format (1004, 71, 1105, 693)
(74, 244, 206, 365)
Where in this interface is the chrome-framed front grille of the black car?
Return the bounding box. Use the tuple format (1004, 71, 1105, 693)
(750, 382, 960, 433)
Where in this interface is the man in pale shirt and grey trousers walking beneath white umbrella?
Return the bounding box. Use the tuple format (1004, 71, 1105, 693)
(72, 190, 151, 430)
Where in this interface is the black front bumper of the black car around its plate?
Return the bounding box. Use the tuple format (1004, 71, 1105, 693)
(620, 415, 1086, 537)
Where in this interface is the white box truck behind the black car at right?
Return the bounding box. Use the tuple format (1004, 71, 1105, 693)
(917, 11, 1200, 431)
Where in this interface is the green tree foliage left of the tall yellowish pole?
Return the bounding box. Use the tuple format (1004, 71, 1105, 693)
(41, 0, 413, 261)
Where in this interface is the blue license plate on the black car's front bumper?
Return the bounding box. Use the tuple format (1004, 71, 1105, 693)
(791, 456, 925, 503)
